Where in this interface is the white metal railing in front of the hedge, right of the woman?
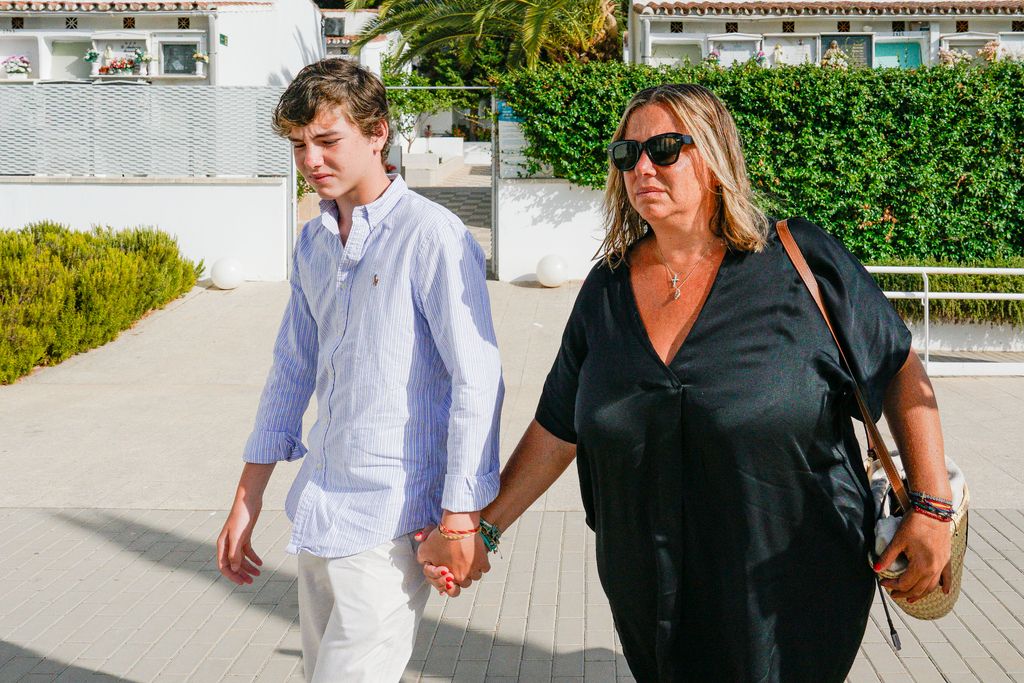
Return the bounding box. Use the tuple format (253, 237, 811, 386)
(867, 265, 1024, 375)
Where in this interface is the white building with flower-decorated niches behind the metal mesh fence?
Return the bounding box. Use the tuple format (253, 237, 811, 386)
(0, 0, 325, 86)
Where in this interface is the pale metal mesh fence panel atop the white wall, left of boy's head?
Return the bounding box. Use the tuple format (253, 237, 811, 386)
(0, 84, 291, 177)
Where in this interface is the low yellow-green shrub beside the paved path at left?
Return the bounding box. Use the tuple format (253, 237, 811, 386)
(0, 222, 204, 384)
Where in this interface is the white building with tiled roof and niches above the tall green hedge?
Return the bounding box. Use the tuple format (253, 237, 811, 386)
(627, 0, 1024, 68)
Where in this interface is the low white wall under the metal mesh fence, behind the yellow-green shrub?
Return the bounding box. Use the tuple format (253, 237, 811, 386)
(0, 177, 291, 281)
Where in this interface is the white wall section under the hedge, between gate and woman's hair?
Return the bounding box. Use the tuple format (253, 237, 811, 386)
(495, 178, 603, 282)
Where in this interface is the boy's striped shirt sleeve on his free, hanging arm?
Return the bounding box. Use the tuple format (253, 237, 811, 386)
(242, 249, 317, 464)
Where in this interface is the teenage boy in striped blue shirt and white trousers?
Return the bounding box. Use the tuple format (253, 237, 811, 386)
(217, 59, 504, 682)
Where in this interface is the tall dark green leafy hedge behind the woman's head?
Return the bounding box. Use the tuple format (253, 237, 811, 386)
(500, 63, 1024, 263)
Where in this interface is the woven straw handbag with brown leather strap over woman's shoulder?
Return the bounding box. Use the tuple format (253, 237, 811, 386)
(776, 220, 970, 626)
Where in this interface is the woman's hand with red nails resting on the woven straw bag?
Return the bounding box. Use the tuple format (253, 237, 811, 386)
(874, 512, 952, 602)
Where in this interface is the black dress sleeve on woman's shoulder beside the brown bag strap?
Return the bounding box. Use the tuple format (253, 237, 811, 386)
(788, 218, 910, 421)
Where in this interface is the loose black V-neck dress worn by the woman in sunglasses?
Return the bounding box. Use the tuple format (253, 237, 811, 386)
(537, 219, 910, 683)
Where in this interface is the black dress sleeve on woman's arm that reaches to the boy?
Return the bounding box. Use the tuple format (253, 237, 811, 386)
(535, 267, 600, 443)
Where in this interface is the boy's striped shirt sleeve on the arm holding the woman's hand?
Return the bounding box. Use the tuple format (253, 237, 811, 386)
(417, 216, 505, 512)
